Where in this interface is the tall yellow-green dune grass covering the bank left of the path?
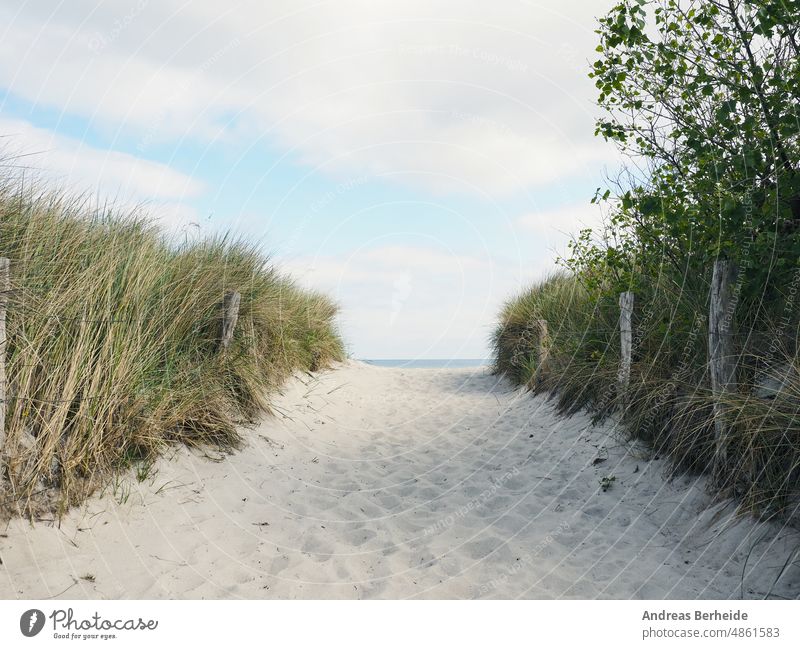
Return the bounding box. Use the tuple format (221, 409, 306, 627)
(0, 182, 343, 511)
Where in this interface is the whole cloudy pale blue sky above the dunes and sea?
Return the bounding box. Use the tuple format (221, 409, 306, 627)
(0, 0, 619, 359)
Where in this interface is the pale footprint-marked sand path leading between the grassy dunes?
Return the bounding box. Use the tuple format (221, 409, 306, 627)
(0, 363, 800, 599)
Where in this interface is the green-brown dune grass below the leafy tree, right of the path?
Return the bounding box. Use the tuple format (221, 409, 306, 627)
(493, 273, 800, 518)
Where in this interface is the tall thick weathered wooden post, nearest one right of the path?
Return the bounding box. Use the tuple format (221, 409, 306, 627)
(708, 259, 736, 484)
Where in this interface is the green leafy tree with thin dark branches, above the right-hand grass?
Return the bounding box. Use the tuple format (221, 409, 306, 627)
(571, 0, 800, 294)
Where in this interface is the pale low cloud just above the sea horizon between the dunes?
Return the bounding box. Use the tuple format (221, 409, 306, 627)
(278, 245, 552, 358)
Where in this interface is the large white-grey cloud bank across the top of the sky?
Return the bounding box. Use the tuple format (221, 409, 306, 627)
(0, 0, 615, 194)
